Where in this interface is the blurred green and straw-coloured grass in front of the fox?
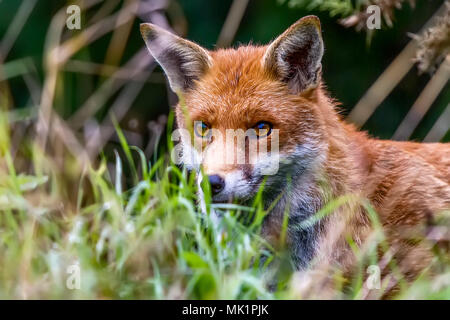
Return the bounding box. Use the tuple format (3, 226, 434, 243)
(0, 112, 450, 299)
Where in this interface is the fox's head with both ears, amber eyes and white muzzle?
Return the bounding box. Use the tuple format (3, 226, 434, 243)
(141, 16, 326, 202)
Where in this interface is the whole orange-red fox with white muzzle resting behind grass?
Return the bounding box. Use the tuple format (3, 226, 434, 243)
(140, 16, 450, 296)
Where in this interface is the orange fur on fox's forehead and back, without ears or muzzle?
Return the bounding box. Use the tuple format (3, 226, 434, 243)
(178, 46, 450, 275)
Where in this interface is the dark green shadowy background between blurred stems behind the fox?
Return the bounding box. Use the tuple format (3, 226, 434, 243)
(0, 0, 450, 146)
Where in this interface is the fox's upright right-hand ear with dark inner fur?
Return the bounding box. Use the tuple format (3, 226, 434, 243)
(263, 16, 324, 94)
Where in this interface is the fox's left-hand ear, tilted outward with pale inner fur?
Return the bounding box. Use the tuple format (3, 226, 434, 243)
(140, 23, 212, 93)
